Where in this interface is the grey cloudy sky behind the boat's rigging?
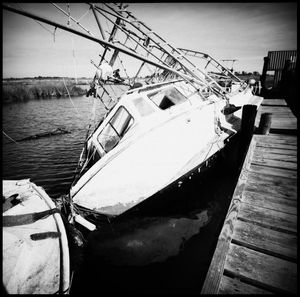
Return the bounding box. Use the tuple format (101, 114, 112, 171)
(2, 2, 297, 78)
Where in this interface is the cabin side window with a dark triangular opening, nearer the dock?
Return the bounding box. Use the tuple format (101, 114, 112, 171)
(148, 87, 187, 110)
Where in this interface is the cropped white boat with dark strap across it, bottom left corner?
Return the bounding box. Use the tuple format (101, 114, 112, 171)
(2, 180, 70, 294)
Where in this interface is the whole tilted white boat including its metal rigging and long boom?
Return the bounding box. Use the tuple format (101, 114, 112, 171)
(3, 3, 262, 230)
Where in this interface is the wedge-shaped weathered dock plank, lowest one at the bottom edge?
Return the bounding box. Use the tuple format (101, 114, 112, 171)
(218, 275, 273, 295)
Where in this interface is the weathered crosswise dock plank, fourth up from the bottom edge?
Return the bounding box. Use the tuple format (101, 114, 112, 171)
(238, 203, 297, 232)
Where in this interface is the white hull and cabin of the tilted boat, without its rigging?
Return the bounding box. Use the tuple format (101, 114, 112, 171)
(70, 80, 262, 224)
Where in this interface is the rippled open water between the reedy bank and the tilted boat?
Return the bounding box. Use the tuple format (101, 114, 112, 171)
(2, 96, 105, 198)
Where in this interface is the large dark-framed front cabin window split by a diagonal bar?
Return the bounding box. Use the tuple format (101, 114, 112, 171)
(98, 106, 133, 153)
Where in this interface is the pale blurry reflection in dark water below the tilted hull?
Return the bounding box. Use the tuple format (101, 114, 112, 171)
(89, 210, 210, 266)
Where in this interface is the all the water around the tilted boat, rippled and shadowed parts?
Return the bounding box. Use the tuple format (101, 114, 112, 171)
(2, 97, 241, 294)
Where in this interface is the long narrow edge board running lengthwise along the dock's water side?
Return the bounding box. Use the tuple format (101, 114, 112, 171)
(201, 141, 255, 294)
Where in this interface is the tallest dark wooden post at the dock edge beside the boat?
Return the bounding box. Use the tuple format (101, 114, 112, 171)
(237, 104, 257, 163)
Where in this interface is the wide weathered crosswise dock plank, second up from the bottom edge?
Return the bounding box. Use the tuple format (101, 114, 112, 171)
(225, 244, 298, 293)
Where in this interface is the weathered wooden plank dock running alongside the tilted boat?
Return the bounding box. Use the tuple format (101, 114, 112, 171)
(201, 99, 297, 294)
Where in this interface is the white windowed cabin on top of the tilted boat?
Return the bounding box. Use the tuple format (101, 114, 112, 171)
(80, 80, 203, 175)
